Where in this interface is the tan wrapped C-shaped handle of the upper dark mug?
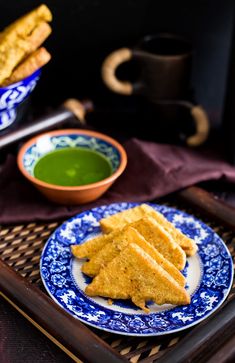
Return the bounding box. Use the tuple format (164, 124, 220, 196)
(101, 48, 133, 95)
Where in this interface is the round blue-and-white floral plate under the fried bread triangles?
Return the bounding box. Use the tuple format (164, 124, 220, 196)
(40, 203, 233, 336)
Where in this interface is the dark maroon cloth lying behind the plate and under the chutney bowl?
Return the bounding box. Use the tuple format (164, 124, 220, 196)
(0, 139, 235, 224)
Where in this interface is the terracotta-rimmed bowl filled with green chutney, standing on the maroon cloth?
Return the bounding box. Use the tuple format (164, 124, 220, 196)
(17, 129, 127, 205)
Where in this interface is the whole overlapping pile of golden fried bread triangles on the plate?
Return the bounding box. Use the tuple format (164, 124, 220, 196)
(72, 205, 193, 312)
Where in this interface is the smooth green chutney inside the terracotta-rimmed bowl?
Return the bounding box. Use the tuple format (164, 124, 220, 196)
(34, 147, 112, 187)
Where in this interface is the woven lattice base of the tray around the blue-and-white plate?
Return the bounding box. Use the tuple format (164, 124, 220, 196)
(0, 191, 235, 363)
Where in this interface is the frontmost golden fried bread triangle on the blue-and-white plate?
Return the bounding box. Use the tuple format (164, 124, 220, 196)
(85, 243, 190, 312)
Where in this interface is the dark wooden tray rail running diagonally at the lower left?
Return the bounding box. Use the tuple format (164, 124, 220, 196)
(0, 260, 125, 363)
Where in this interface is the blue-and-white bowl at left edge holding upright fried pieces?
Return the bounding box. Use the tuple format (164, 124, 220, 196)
(0, 69, 41, 131)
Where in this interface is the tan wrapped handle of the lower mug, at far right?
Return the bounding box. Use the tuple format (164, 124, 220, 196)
(186, 106, 210, 146)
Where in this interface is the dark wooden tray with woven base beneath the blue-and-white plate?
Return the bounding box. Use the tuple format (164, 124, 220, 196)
(0, 187, 235, 363)
